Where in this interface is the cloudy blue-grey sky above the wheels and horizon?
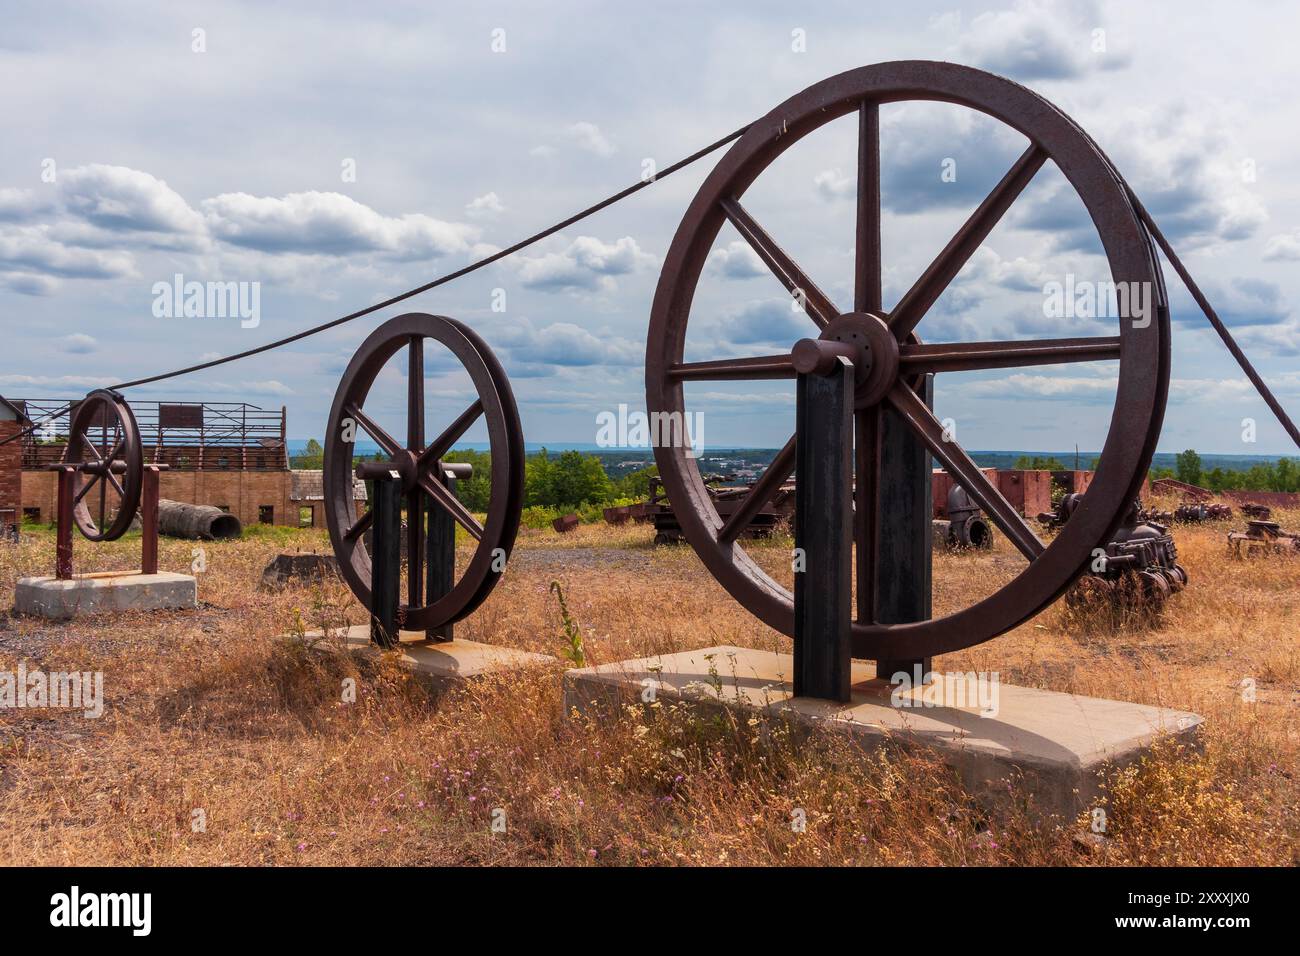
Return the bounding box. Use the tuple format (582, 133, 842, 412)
(0, 0, 1300, 454)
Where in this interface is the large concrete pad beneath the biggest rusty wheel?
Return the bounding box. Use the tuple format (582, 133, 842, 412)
(564, 646, 1201, 817)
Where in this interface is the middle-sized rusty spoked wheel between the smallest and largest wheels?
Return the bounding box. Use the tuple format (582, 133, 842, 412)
(324, 312, 524, 630)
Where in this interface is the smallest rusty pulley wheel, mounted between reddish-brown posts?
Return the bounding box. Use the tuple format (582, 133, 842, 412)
(62, 389, 144, 541)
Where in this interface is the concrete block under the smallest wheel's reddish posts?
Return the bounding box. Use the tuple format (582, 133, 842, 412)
(13, 571, 199, 620)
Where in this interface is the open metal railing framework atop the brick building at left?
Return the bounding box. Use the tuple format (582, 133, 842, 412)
(10, 398, 289, 471)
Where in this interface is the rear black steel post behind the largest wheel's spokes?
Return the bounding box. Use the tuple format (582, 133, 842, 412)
(876, 375, 935, 680)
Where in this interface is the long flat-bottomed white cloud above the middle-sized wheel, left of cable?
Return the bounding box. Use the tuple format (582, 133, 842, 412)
(203, 190, 476, 259)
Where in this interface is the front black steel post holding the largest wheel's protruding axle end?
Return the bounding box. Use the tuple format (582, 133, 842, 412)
(794, 358, 854, 702)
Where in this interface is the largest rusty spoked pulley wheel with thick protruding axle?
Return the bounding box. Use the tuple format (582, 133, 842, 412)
(646, 61, 1170, 659)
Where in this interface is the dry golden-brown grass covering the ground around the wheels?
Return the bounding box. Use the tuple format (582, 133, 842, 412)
(0, 504, 1300, 865)
